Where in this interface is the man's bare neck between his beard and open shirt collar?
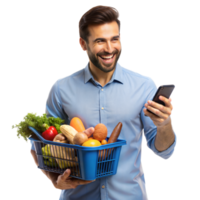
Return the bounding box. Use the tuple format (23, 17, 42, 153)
(89, 62, 115, 87)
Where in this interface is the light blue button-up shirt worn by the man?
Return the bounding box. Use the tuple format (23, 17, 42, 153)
(30, 62, 177, 200)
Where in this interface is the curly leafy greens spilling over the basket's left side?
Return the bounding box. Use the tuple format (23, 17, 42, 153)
(9, 111, 65, 143)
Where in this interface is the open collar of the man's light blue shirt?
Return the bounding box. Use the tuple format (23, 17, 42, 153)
(85, 62, 124, 84)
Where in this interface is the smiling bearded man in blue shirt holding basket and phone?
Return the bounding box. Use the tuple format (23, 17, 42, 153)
(31, 6, 176, 200)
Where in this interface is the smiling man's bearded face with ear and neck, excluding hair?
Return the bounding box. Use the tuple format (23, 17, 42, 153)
(79, 21, 122, 86)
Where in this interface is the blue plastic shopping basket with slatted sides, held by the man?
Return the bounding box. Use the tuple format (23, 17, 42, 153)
(29, 127, 126, 180)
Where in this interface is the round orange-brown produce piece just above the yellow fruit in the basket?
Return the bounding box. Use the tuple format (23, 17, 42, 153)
(93, 123, 108, 141)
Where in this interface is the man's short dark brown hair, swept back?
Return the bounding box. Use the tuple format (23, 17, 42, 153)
(77, 5, 122, 43)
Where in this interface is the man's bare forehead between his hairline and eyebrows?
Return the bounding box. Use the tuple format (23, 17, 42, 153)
(88, 21, 119, 40)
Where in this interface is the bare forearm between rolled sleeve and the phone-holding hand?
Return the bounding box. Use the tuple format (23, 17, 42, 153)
(155, 122, 175, 151)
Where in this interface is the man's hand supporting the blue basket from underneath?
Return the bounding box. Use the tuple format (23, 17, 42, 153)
(52, 169, 93, 190)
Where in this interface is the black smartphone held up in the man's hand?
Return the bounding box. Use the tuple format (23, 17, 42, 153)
(147, 84, 176, 114)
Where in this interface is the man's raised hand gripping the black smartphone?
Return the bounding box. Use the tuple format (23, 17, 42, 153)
(143, 96, 174, 127)
